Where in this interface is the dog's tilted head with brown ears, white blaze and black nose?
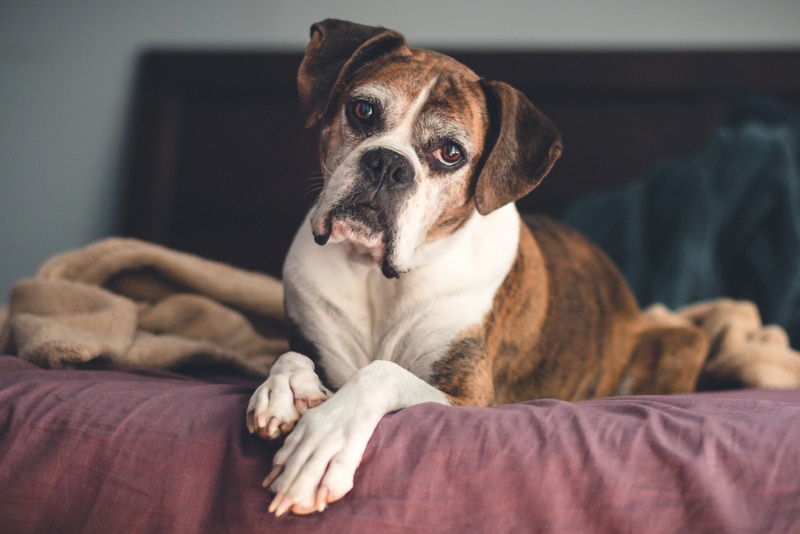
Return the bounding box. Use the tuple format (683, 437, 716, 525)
(298, 20, 561, 278)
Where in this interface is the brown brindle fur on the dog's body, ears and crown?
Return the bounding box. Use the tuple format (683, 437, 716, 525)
(291, 21, 706, 405)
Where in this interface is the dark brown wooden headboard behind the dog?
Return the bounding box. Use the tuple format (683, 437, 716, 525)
(120, 50, 800, 275)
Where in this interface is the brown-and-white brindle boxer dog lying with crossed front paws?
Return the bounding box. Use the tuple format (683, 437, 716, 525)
(247, 20, 720, 515)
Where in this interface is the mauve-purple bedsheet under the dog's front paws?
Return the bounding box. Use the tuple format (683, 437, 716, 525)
(0, 357, 800, 533)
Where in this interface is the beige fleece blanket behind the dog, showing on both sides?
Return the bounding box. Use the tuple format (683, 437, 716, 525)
(0, 238, 800, 387)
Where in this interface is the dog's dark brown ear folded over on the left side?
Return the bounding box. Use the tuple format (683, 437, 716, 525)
(297, 19, 406, 127)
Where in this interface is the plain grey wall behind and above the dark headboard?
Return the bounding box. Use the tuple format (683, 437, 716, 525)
(0, 0, 800, 304)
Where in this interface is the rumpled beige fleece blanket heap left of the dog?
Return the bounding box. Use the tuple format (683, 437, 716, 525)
(0, 238, 288, 376)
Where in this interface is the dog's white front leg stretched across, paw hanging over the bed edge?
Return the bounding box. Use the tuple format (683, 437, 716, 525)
(264, 360, 448, 516)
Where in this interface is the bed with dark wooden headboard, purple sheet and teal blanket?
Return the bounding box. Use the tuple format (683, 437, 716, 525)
(0, 50, 800, 532)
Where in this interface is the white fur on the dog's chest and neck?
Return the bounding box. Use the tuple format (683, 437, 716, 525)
(284, 204, 520, 388)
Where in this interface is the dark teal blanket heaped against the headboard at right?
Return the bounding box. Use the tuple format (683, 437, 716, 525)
(563, 98, 800, 347)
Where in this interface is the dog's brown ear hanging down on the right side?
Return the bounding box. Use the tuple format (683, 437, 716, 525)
(475, 80, 563, 215)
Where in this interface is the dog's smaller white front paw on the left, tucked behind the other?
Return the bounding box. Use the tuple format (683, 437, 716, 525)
(247, 352, 330, 439)
